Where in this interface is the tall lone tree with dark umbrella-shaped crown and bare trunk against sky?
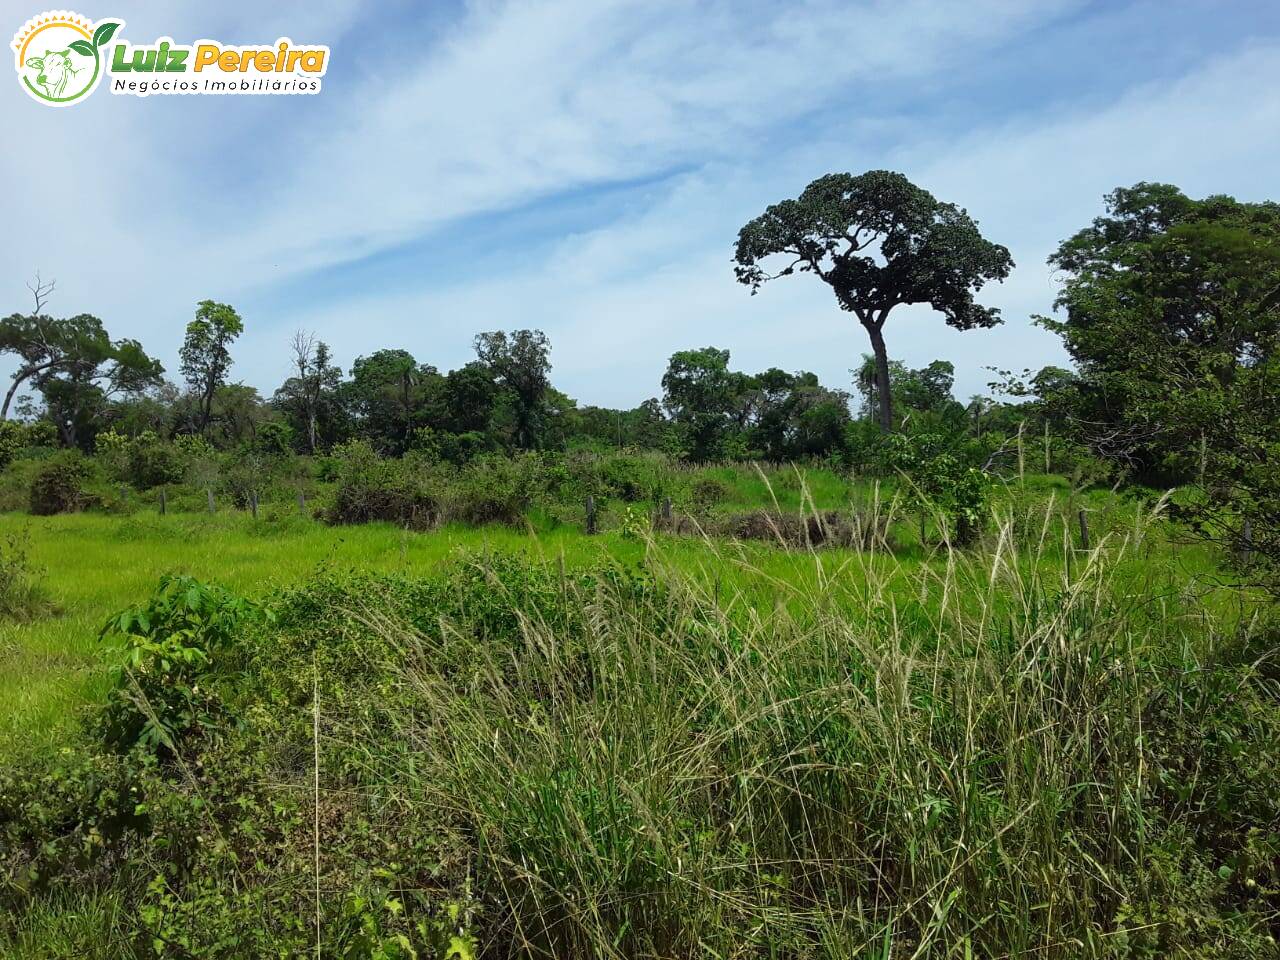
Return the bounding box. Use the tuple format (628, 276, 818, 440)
(733, 170, 1014, 431)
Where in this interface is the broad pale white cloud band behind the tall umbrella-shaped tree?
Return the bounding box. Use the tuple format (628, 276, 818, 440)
(257, 35, 1280, 404)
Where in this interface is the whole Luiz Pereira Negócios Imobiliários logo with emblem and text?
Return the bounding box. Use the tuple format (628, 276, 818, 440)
(13, 10, 329, 106)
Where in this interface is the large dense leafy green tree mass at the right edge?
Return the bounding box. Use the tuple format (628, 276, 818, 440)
(1041, 183, 1280, 568)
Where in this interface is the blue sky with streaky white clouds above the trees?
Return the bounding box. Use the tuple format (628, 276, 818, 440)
(0, 0, 1280, 407)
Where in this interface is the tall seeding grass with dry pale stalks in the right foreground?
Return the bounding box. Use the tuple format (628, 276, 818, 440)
(322, 499, 1275, 960)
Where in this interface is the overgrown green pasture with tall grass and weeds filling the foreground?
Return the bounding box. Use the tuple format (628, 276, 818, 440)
(0, 468, 1280, 960)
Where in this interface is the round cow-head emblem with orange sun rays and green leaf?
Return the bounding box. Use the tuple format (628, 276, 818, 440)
(13, 10, 124, 106)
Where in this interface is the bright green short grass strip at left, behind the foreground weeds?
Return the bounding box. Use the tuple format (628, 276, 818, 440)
(0, 512, 607, 756)
